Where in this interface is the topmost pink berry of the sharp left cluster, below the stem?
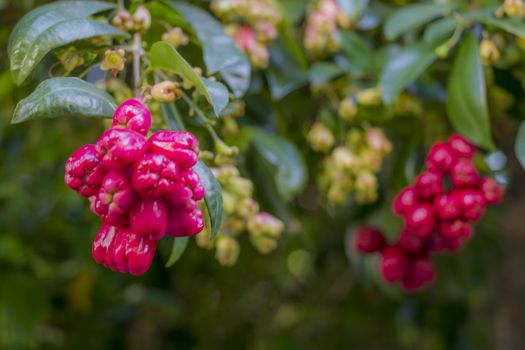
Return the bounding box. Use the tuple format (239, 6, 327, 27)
(112, 98, 151, 136)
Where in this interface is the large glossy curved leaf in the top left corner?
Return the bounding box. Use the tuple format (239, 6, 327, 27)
(7, 1, 128, 85)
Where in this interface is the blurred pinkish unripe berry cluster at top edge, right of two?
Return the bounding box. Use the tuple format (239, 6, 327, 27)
(304, 0, 351, 56)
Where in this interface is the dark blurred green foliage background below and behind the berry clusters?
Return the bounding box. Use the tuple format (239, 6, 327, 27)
(0, 0, 525, 350)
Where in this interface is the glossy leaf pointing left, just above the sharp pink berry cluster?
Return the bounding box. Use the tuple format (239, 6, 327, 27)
(11, 77, 117, 124)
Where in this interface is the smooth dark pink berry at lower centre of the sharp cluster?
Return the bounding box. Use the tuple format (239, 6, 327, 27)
(130, 198, 168, 240)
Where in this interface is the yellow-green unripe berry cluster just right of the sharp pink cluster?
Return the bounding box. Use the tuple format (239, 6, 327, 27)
(197, 164, 284, 266)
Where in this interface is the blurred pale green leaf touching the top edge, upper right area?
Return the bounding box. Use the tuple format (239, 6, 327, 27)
(383, 4, 450, 40)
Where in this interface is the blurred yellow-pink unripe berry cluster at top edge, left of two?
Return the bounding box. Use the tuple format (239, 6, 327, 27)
(211, 0, 281, 69)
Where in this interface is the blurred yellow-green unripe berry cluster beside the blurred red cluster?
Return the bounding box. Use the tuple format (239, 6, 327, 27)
(307, 123, 392, 204)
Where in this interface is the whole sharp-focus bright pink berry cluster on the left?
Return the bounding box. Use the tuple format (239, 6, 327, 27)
(65, 98, 204, 275)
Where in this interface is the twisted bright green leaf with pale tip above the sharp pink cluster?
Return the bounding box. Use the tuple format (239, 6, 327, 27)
(150, 41, 228, 116)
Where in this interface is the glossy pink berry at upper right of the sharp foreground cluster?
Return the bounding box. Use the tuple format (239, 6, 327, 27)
(149, 131, 199, 169)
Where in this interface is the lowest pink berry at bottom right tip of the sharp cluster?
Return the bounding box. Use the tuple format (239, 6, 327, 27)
(111, 229, 157, 275)
